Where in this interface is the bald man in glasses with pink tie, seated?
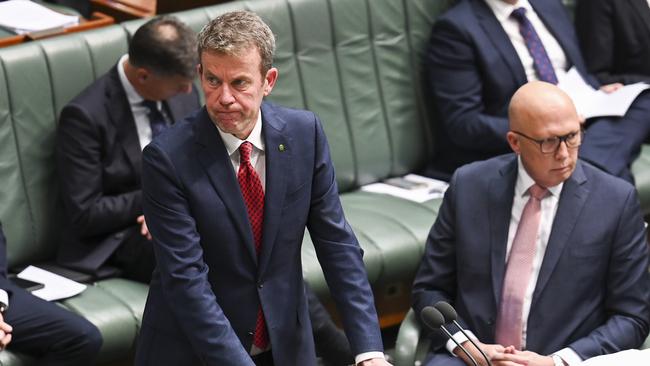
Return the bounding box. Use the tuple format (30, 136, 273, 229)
(413, 81, 650, 366)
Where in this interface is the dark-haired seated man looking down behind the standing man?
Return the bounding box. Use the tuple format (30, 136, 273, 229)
(56, 16, 199, 283)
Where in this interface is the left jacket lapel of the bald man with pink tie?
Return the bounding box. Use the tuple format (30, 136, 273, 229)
(488, 157, 517, 308)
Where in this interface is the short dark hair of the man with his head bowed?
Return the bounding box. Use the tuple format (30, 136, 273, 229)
(129, 16, 198, 79)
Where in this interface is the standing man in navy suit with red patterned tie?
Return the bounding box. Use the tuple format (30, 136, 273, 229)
(136, 11, 388, 366)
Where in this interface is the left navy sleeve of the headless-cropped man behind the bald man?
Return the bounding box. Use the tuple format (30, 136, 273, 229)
(427, 19, 508, 151)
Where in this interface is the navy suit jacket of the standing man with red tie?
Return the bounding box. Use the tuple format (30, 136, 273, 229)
(136, 103, 383, 366)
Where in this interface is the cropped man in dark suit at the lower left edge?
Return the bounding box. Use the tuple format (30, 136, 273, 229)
(0, 225, 102, 366)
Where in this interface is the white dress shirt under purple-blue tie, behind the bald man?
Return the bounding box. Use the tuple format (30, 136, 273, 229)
(485, 0, 568, 81)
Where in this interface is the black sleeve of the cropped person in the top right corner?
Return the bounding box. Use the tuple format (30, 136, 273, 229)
(575, 0, 650, 84)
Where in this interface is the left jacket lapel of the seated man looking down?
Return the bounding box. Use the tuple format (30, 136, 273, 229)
(105, 66, 142, 184)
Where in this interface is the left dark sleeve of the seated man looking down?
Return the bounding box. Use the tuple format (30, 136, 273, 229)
(56, 106, 142, 237)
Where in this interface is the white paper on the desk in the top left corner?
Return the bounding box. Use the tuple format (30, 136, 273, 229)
(0, 0, 79, 34)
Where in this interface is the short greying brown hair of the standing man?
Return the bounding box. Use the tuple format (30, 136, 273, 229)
(198, 11, 275, 76)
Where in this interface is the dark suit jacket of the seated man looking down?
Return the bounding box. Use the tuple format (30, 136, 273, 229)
(56, 66, 199, 272)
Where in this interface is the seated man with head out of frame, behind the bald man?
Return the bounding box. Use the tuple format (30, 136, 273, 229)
(427, 0, 650, 181)
